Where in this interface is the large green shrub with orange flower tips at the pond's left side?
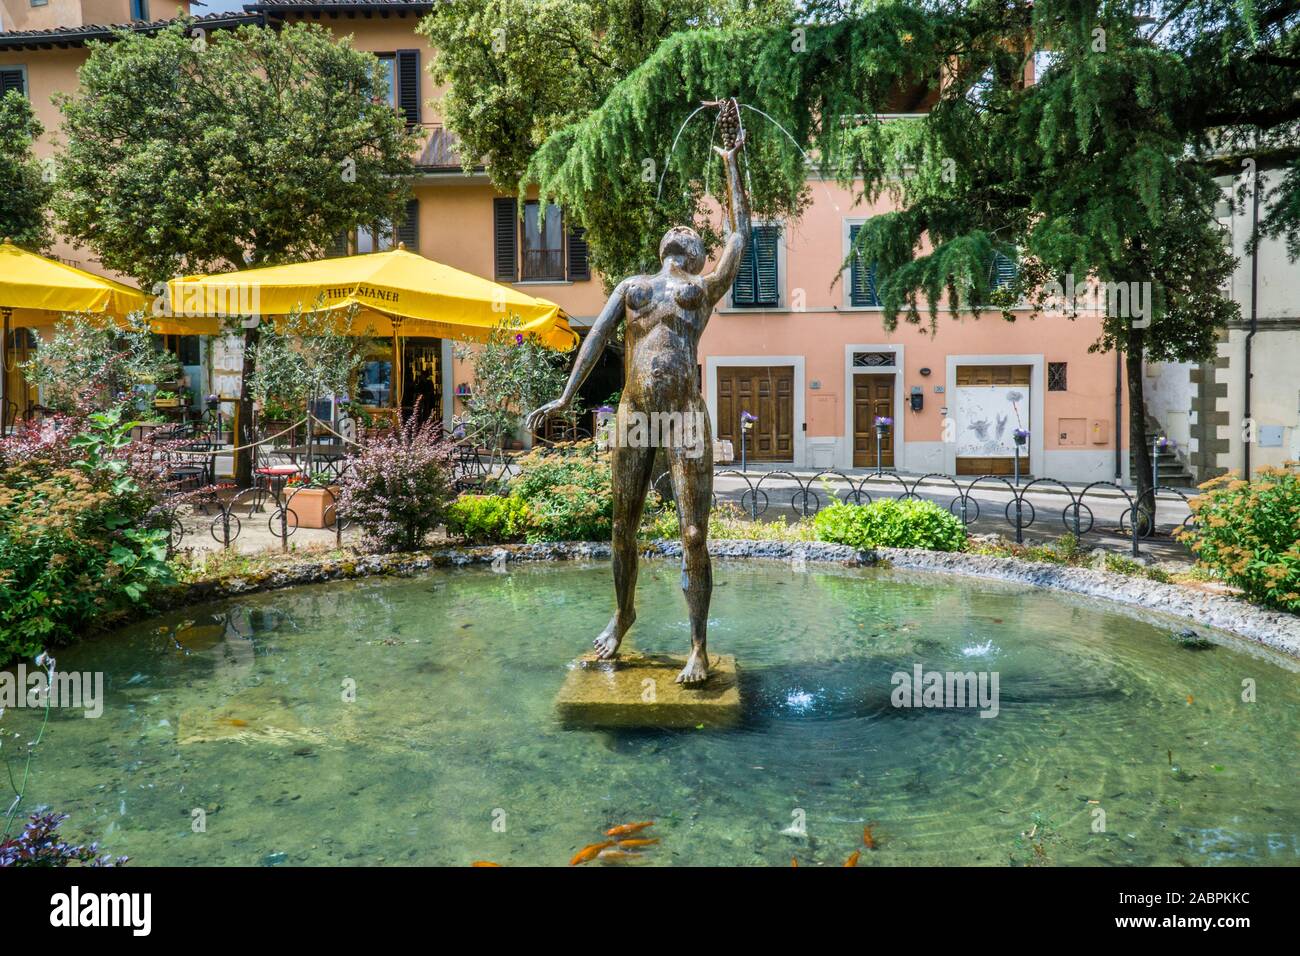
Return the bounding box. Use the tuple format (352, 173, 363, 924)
(0, 412, 172, 663)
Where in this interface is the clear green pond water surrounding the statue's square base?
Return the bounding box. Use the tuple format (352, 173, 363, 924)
(0, 562, 1300, 866)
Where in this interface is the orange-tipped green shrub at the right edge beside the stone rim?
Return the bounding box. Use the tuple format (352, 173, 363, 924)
(1179, 468, 1300, 614)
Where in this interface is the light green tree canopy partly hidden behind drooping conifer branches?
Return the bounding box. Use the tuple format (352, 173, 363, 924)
(420, 0, 800, 283)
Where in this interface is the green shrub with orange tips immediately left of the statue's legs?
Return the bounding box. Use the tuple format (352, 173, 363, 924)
(510, 441, 614, 541)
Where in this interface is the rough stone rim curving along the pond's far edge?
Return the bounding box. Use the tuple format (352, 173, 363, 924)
(155, 540, 1300, 658)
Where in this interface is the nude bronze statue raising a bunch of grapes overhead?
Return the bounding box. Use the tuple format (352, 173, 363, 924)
(528, 100, 750, 684)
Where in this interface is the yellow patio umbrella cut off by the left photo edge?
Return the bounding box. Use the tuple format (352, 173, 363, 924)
(0, 239, 154, 423)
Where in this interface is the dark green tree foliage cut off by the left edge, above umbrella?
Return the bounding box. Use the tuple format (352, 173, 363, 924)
(0, 90, 53, 252)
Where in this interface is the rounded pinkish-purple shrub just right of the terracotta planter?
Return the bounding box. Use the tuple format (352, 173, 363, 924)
(338, 408, 454, 551)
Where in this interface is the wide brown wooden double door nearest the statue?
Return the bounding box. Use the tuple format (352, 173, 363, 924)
(718, 365, 794, 462)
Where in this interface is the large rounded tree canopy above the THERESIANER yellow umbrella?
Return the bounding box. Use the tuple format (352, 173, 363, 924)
(56, 20, 416, 287)
